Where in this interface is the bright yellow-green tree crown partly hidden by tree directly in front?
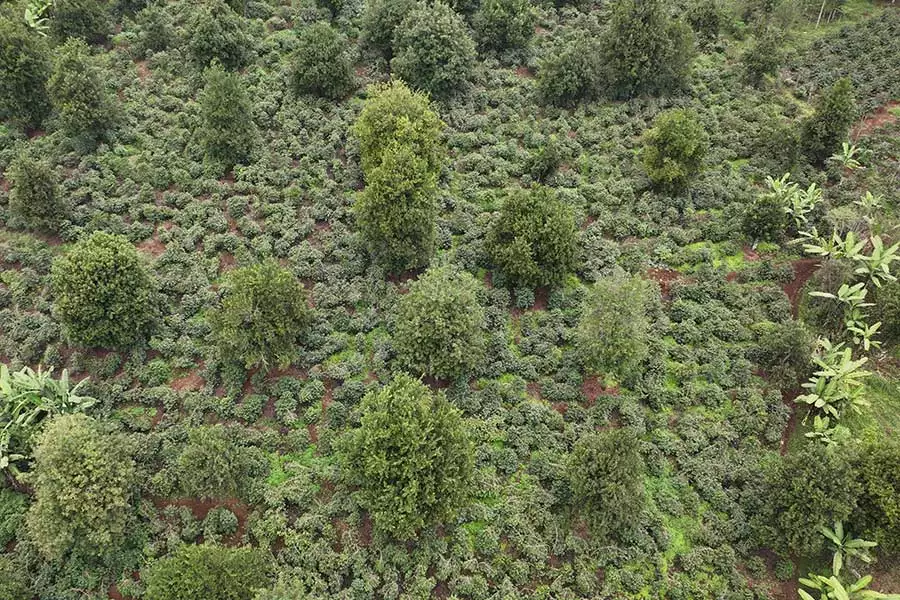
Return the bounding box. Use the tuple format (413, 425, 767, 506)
(353, 80, 445, 177)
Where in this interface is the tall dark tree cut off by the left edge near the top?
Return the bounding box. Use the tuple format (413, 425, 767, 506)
(0, 17, 50, 127)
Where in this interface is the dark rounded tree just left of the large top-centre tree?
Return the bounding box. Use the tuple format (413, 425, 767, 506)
(292, 22, 354, 100)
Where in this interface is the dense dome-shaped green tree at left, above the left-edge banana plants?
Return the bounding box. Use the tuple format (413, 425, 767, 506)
(51, 231, 156, 348)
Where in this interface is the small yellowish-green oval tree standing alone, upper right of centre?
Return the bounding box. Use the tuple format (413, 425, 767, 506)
(642, 109, 709, 191)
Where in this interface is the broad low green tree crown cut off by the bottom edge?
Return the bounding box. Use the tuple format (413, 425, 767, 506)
(141, 544, 270, 600)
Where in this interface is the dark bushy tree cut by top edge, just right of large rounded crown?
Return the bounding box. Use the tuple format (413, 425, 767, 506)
(472, 0, 535, 50)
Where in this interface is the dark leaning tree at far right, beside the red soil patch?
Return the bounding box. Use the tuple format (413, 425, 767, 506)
(800, 77, 856, 165)
